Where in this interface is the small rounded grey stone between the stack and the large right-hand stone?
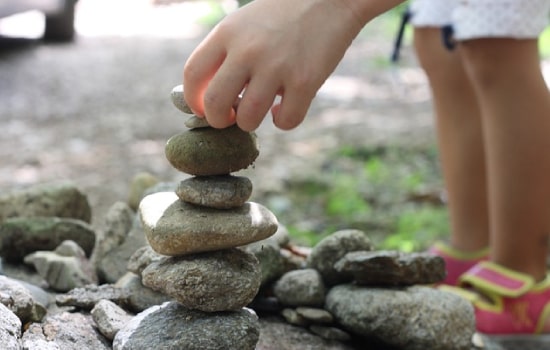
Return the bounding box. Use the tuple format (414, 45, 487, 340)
(273, 269, 325, 306)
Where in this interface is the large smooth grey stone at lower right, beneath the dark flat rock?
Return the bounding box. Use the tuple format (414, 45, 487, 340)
(325, 284, 475, 350)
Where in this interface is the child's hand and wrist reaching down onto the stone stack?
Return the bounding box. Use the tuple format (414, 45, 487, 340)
(184, 0, 403, 130)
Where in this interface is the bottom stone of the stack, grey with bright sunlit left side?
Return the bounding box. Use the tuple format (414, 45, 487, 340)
(113, 302, 260, 350)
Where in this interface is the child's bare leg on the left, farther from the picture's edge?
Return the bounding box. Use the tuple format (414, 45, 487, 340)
(414, 28, 492, 252)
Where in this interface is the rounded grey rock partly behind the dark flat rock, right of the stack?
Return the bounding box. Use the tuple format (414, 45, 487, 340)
(307, 230, 373, 286)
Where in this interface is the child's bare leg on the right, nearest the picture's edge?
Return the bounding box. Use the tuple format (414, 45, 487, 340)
(459, 39, 550, 280)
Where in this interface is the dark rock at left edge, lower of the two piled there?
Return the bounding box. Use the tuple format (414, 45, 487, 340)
(0, 217, 95, 262)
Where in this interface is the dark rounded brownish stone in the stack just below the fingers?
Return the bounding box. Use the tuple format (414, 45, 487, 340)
(165, 125, 260, 176)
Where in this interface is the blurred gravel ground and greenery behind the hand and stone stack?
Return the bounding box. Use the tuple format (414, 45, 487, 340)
(0, 0, 550, 250)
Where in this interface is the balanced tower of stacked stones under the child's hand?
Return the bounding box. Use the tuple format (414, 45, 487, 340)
(134, 86, 278, 349)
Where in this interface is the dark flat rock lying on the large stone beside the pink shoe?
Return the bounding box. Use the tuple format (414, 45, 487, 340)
(334, 251, 446, 285)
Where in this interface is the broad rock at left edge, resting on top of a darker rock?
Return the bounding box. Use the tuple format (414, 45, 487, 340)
(0, 182, 92, 223)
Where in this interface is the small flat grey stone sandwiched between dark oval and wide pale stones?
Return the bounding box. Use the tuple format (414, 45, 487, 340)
(176, 175, 252, 209)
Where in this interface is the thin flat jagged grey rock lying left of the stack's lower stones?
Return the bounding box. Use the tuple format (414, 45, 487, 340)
(55, 284, 130, 310)
